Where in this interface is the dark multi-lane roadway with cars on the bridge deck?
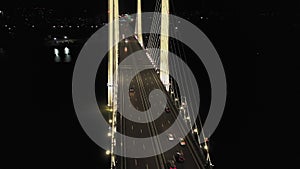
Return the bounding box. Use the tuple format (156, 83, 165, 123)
(116, 34, 204, 169)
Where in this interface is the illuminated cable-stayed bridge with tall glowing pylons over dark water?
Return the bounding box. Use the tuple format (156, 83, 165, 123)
(107, 0, 213, 169)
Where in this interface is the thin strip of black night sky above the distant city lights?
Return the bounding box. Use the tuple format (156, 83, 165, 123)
(1, 0, 300, 12)
